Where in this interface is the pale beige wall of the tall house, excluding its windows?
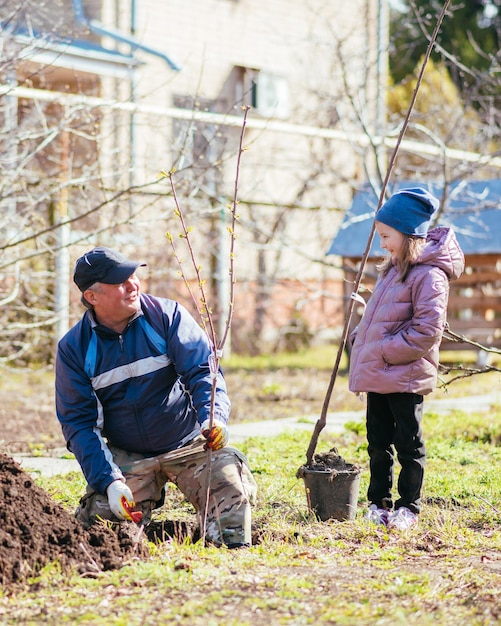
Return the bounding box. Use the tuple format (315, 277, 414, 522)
(93, 0, 378, 341)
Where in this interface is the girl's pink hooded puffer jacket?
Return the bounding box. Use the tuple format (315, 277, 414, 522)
(350, 228, 464, 395)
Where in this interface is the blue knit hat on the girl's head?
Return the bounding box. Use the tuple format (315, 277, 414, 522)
(376, 187, 440, 237)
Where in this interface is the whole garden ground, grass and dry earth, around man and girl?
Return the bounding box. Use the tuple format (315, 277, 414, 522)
(0, 358, 501, 626)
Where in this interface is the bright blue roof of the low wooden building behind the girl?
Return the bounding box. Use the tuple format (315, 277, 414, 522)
(326, 179, 501, 258)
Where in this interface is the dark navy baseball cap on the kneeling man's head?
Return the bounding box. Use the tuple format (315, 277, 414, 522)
(73, 247, 146, 292)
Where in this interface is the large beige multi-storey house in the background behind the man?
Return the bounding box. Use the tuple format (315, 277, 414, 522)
(0, 0, 382, 350)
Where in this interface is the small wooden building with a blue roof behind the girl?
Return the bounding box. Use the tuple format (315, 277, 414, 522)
(327, 180, 501, 350)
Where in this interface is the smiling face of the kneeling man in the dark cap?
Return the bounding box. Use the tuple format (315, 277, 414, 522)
(84, 274, 141, 331)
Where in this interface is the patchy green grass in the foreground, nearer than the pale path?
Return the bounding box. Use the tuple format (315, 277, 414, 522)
(0, 402, 501, 626)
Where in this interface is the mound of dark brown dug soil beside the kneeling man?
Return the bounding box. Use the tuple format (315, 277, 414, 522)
(0, 454, 148, 586)
